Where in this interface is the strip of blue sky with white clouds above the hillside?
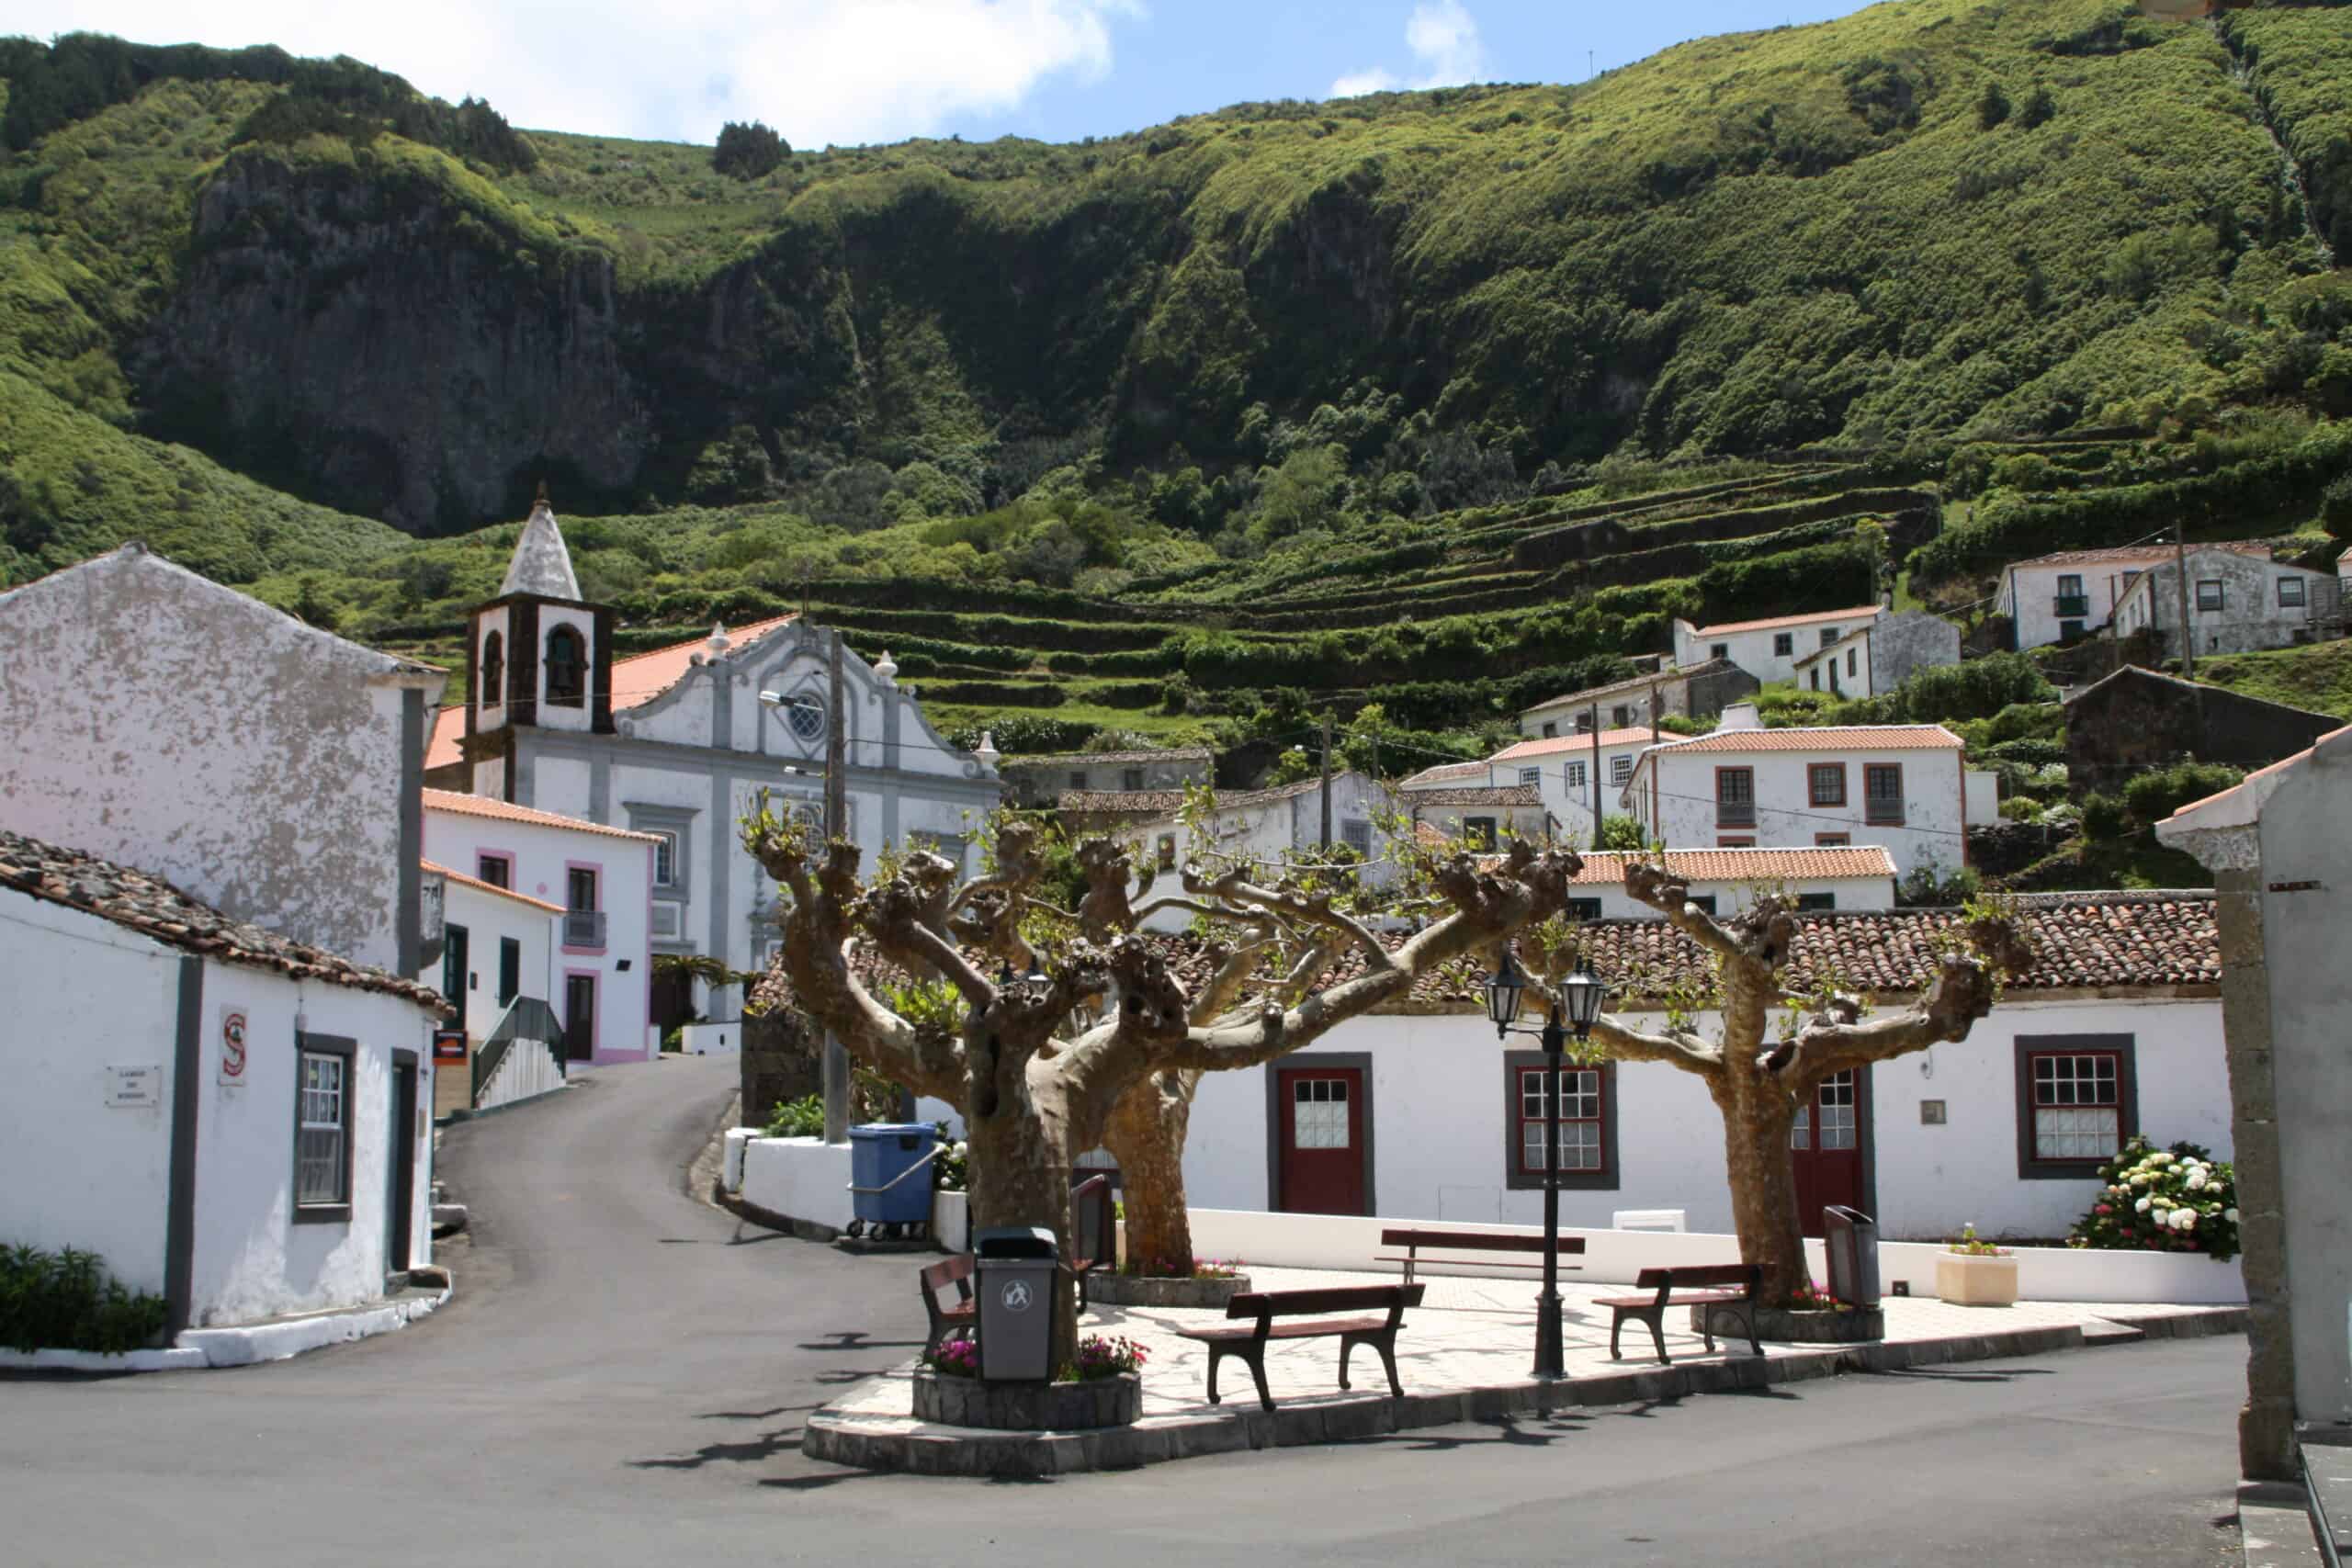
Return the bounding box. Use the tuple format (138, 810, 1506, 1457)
(32, 0, 1860, 146)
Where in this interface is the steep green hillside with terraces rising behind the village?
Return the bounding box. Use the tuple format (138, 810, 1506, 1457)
(0, 0, 2352, 750)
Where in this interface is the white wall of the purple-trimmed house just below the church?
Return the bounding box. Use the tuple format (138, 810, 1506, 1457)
(425, 802, 661, 1063)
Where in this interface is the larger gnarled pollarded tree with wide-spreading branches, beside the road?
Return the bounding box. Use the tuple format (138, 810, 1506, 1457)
(743, 802, 1578, 1361)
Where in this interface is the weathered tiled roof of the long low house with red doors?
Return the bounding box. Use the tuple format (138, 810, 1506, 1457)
(752, 891, 2221, 1020)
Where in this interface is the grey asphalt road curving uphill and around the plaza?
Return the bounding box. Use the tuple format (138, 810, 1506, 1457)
(0, 1060, 2244, 1568)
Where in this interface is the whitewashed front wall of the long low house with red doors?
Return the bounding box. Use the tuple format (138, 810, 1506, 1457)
(1185, 1001, 2230, 1239)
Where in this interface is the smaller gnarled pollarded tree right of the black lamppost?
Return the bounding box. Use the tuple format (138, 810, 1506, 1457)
(1521, 861, 2030, 1307)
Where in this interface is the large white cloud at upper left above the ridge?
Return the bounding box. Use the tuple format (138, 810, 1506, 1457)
(28, 0, 1143, 146)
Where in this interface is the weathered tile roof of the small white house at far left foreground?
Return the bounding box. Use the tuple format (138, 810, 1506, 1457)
(0, 828, 449, 1016)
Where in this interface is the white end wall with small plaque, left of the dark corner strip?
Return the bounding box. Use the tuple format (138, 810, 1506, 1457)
(0, 891, 179, 1295)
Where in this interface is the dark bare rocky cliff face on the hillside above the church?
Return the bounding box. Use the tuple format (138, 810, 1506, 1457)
(131, 157, 656, 531)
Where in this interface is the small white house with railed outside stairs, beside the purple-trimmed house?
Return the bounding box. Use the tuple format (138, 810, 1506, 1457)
(416, 861, 564, 1117)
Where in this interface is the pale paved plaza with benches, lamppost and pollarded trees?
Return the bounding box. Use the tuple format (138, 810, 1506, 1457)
(809, 1265, 2244, 1474)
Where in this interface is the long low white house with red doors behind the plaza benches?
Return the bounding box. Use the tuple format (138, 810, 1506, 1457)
(1185, 894, 2230, 1239)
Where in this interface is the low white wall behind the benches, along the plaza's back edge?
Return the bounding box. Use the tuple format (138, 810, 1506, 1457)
(1193, 1208, 2246, 1304)
